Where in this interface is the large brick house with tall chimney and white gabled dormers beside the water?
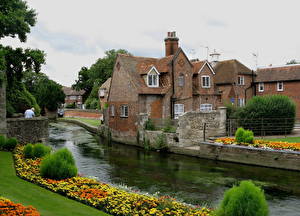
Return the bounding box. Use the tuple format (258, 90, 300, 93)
(106, 32, 253, 136)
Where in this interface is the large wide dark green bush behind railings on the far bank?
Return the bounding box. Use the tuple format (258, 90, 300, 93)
(238, 95, 296, 135)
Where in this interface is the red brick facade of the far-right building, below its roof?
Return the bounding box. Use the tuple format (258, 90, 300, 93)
(256, 81, 300, 119)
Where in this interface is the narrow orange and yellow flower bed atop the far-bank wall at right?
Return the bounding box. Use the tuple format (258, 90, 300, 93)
(215, 137, 300, 151)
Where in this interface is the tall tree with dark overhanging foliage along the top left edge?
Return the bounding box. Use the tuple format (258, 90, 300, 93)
(0, 0, 45, 134)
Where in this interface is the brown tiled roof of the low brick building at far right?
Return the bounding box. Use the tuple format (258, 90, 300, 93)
(255, 64, 300, 82)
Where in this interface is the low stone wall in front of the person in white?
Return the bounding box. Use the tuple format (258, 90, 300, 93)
(7, 117, 49, 144)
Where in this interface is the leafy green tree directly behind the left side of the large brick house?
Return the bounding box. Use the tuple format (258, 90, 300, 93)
(72, 49, 131, 101)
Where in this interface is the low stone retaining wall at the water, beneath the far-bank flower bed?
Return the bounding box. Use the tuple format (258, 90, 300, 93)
(170, 142, 300, 171)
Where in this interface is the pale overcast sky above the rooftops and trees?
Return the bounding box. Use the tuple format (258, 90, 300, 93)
(0, 0, 300, 86)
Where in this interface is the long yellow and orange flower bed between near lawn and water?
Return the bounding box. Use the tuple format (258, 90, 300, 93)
(14, 146, 211, 216)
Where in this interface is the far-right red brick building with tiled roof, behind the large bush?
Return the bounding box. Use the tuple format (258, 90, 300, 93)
(255, 64, 300, 118)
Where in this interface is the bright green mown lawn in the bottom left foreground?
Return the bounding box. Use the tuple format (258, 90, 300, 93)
(0, 152, 108, 216)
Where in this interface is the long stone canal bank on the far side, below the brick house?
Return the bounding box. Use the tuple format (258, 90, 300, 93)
(60, 119, 300, 171)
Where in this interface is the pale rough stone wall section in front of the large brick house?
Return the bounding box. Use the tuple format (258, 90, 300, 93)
(176, 107, 226, 145)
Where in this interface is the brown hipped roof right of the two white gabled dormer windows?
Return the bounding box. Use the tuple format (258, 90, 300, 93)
(214, 59, 252, 84)
